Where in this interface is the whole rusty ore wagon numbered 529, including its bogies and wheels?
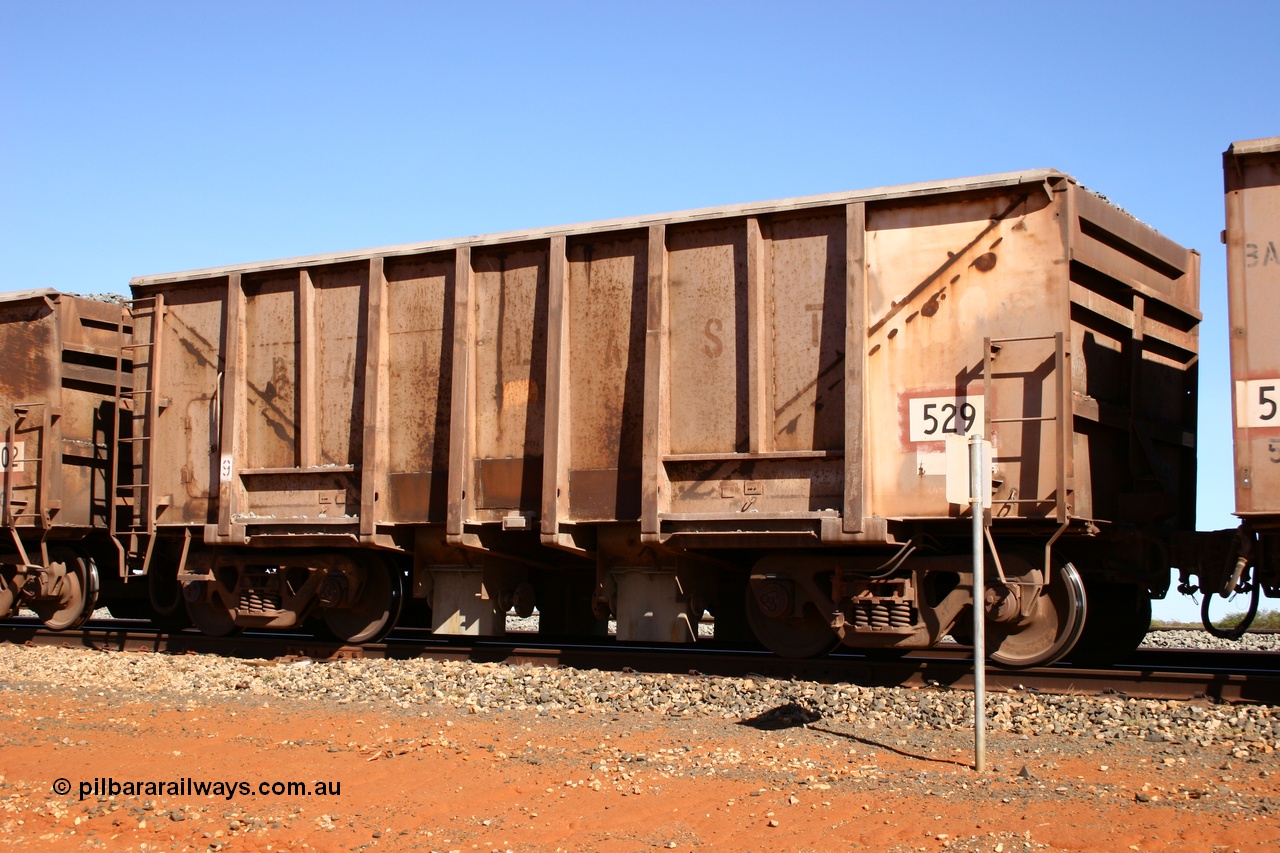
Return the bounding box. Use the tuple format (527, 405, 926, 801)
(17, 145, 1280, 666)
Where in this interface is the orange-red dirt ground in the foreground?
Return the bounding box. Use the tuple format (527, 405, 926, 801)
(0, 685, 1280, 853)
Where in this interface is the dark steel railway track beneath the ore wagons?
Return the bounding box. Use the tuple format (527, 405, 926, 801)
(0, 620, 1280, 704)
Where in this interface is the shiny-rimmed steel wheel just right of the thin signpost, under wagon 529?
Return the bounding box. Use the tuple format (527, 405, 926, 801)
(987, 562, 1085, 669)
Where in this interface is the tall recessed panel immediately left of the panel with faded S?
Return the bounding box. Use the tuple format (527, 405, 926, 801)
(568, 233, 649, 520)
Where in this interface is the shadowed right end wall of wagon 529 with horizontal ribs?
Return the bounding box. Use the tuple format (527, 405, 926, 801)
(1066, 187, 1199, 529)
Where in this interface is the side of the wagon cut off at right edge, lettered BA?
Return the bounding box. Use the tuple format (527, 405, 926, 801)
(1222, 137, 1280, 516)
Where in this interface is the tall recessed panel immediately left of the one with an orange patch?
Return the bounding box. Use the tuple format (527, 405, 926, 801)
(384, 255, 454, 521)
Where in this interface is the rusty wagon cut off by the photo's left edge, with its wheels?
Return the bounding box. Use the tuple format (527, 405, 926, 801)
(0, 289, 131, 629)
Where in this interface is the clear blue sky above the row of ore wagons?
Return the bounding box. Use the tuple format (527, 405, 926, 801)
(0, 0, 1280, 617)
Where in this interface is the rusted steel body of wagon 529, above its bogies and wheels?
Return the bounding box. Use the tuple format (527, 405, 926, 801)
(124, 166, 1199, 544)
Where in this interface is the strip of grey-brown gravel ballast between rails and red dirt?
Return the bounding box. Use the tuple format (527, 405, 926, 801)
(0, 643, 1280, 757)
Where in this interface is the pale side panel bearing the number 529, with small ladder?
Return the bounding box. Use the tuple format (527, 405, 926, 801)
(865, 181, 1071, 519)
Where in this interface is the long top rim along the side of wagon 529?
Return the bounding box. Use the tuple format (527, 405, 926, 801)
(129, 169, 1078, 288)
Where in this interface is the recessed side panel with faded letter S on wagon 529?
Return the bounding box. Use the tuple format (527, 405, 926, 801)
(667, 219, 749, 453)
